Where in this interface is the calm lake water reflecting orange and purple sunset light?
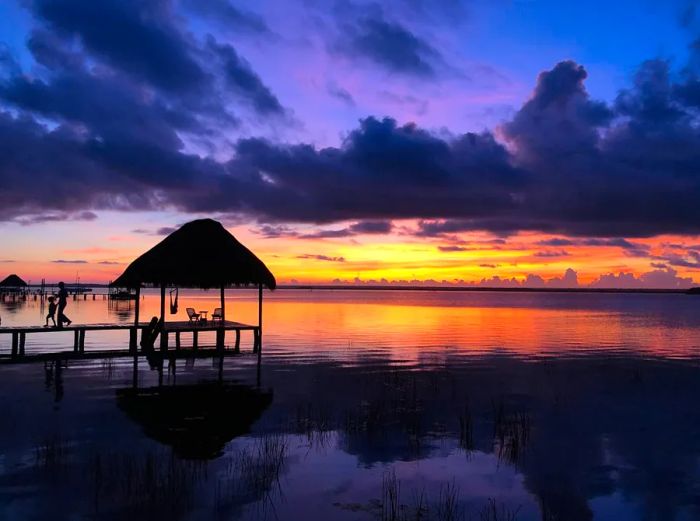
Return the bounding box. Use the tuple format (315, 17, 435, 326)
(0, 290, 700, 521)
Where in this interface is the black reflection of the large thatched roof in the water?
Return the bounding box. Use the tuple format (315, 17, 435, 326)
(117, 383, 272, 459)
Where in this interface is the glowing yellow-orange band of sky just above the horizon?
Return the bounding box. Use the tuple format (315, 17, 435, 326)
(0, 212, 700, 284)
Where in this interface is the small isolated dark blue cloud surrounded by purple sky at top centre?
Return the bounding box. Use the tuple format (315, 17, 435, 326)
(334, 13, 441, 78)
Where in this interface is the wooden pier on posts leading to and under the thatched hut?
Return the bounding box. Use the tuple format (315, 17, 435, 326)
(0, 320, 262, 362)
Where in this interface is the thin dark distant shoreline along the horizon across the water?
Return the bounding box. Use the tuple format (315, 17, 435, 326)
(28, 284, 688, 294)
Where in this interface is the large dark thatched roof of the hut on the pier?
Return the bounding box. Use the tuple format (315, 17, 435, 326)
(112, 219, 277, 289)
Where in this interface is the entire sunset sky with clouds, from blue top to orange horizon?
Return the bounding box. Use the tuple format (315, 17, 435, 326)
(0, 0, 700, 288)
